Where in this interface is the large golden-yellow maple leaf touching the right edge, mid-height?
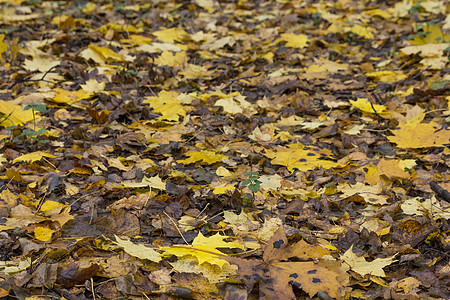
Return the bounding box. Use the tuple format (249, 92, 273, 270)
(387, 122, 450, 149)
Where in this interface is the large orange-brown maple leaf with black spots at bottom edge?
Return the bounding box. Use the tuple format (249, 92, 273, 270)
(223, 226, 348, 299)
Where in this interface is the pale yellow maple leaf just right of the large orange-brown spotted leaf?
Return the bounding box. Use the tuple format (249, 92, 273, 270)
(341, 245, 396, 277)
